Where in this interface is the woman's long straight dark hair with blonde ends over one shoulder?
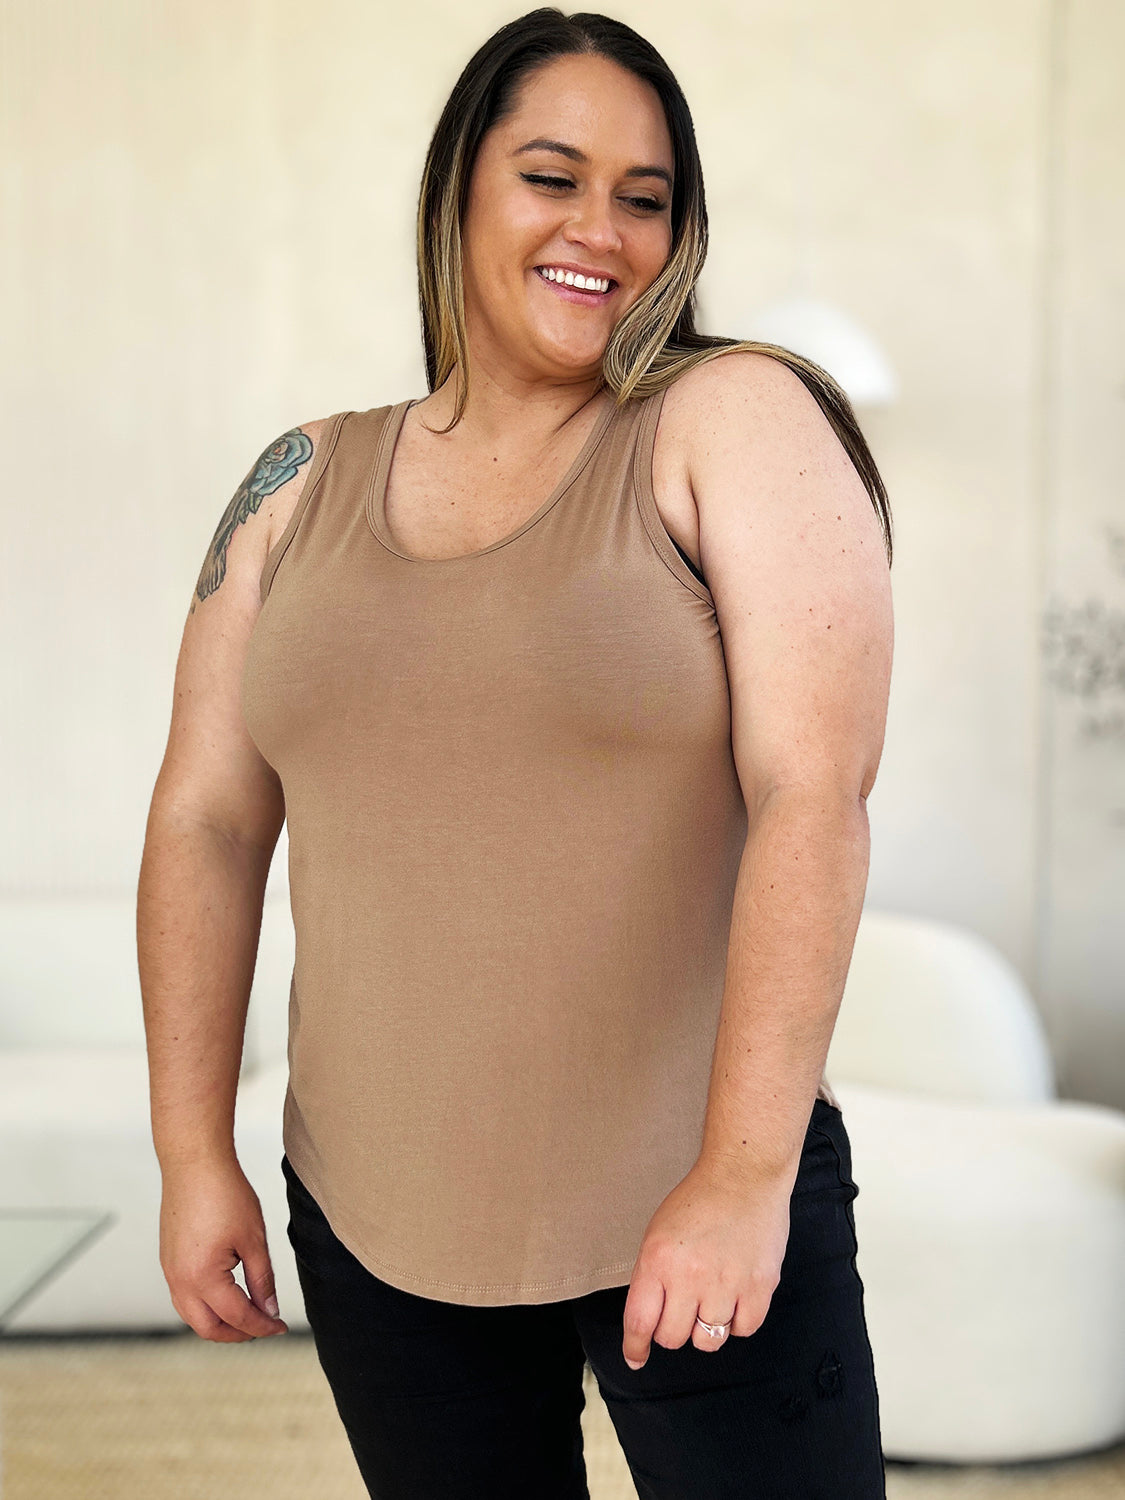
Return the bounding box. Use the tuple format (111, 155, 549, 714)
(417, 6, 893, 566)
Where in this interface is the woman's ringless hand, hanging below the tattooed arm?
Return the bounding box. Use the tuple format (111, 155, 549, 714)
(161, 1158, 290, 1344)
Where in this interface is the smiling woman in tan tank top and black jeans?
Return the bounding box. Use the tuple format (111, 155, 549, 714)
(138, 9, 891, 1500)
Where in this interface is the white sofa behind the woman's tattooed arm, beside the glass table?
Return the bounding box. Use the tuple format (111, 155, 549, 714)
(0, 894, 300, 1332)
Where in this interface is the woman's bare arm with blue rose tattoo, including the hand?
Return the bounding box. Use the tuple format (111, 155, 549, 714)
(137, 419, 327, 1343)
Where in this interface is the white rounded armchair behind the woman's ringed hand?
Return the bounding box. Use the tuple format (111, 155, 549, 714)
(828, 911, 1125, 1463)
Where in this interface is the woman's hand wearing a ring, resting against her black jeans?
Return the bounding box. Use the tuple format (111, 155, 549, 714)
(623, 1160, 797, 1370)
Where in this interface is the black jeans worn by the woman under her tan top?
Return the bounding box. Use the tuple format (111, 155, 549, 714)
(282, 1098, 885, 1500)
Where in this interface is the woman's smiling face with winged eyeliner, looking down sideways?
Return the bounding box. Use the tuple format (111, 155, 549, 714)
(464, 57, 674, 384)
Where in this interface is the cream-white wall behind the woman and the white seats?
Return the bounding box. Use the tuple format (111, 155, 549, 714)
(0, 0, 1125, 1106)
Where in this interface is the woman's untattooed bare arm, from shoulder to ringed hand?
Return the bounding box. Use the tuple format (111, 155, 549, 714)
(624, 351, 893, 1367)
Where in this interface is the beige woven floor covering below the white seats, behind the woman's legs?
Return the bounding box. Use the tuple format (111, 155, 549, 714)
(0, 1331, 1125, 1500)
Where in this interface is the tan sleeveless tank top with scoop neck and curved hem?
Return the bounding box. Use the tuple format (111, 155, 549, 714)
(242, 393, 837, 1307)
